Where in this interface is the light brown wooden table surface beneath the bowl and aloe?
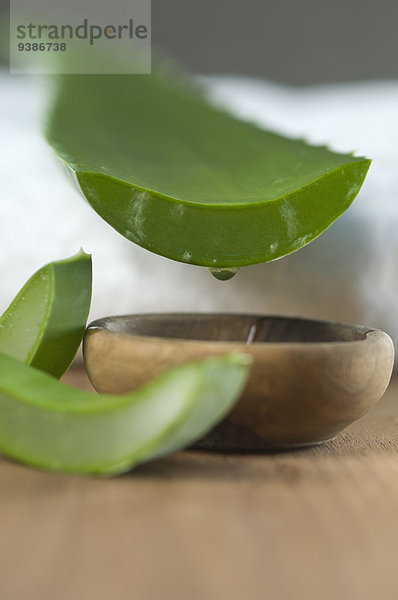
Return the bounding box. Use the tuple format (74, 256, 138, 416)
(0, 371, 398, 600)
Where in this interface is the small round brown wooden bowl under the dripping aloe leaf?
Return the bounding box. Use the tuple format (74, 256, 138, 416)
(83, 314, 394, 451)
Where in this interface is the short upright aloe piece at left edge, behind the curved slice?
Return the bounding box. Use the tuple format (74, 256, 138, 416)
(0, 251, 91, 377)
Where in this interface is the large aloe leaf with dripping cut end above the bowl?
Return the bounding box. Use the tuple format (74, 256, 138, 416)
(46, 67, 370, 277)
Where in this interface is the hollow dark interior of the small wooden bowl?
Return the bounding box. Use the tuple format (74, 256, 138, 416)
(90, 313, 370, 343)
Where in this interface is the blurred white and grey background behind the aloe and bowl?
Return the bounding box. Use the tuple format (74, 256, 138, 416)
(0, 0, 398, 341)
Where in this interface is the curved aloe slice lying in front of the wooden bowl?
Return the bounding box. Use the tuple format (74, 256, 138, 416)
(0, 353, 250, 475)
